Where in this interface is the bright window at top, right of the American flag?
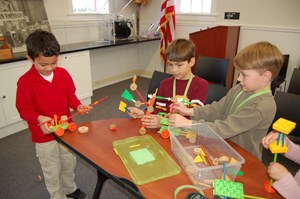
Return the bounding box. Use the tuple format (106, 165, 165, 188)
(175, 0, 212, 14)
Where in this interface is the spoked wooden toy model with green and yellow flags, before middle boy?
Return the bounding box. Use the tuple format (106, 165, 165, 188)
(119, 76, 204, 138)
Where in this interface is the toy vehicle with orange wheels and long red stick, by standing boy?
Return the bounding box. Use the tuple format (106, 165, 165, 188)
(38, 96, 108, 136)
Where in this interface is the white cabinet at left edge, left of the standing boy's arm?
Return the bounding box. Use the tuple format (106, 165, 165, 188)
(0, 61, 31, 127)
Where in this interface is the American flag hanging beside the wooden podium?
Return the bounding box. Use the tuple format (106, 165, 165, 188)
(160, 0, 175, 67)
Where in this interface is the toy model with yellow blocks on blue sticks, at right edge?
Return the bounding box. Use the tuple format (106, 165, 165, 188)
(264, 118, 296, 193)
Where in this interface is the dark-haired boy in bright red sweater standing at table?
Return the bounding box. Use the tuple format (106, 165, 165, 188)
(16, 30, 91, 199)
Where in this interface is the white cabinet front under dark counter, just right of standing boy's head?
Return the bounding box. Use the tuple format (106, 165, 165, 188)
(58, 51, 93, 100)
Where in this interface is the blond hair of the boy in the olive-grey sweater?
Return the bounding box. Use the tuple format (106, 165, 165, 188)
(233, 41, 284, 80)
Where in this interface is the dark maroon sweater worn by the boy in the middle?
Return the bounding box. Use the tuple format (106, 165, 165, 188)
(155, 76, 208, 113)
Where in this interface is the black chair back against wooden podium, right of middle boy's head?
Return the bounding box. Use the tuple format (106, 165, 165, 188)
(194, 56, 229, 86)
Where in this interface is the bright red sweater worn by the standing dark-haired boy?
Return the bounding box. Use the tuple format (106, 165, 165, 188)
(16, 65, 81, 143)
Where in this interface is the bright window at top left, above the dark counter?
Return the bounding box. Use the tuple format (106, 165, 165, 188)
(71, 0, 109, 14)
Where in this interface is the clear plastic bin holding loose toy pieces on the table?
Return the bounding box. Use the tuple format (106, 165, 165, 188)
(169, 124, 245, 189)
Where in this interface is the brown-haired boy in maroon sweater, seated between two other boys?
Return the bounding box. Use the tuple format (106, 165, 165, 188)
(128, 39, 208, 128)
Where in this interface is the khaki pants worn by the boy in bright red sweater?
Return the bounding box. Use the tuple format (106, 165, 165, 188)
(35, 140, 77, 199)
